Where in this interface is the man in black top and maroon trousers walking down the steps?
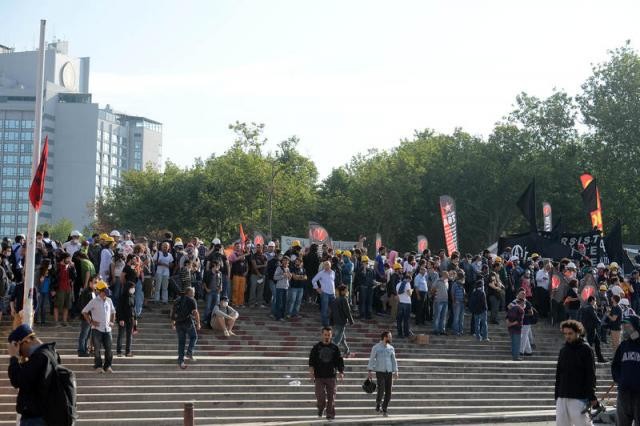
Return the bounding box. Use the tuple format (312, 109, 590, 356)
(309, 327, 344, 420)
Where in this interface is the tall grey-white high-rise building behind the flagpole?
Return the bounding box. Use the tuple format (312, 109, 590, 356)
(0, 41, 162, 237)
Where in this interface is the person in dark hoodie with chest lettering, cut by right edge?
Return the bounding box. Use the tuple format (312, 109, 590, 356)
(611, 315, 640, 426)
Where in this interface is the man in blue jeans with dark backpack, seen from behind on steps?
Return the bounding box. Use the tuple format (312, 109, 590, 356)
(171, 287, 200, 370)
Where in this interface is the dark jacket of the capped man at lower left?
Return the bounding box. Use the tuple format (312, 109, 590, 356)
(9, 343, 60, 418)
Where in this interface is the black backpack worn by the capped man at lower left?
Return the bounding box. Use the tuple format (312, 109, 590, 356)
(42, 350, 78, 426)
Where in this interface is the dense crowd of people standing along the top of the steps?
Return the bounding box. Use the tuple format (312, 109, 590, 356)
(0, 230, 640, 417)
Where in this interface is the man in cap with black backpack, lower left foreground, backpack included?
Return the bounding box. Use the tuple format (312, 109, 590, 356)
(8, 324, 77, 426)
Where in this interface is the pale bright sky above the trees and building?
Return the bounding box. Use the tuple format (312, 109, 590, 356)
(0, 0, 640, 178)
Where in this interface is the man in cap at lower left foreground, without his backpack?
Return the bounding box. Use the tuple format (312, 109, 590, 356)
(8, 324, 60, 425)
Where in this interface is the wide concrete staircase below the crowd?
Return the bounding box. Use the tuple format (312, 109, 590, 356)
(0, 305, 615, 426)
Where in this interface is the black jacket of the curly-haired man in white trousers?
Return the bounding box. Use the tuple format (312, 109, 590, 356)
(555, 338, 596, 401)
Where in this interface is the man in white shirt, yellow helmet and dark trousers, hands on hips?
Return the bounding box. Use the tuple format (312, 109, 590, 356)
(82, 281, 116, 373)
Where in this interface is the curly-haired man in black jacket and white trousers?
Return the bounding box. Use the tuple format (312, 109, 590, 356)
(555, 320, 598, 425)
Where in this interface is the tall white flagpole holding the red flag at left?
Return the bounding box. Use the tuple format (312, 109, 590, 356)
(22, 19, 47, 326)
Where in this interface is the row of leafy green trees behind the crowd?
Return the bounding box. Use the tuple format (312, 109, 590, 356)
(96, 43, 640, 251)
